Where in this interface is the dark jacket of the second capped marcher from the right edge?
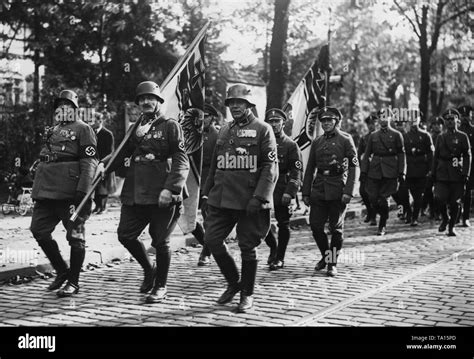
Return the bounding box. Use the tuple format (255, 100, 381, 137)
(403, 128, 434, 178)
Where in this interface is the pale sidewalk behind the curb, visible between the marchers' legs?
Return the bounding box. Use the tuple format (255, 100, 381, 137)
(0, 197, 386, 283)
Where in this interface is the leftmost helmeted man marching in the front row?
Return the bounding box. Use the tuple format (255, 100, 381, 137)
(30, 90, 97, 297)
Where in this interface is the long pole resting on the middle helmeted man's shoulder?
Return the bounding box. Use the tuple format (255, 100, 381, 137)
(69, 21, 211, 222)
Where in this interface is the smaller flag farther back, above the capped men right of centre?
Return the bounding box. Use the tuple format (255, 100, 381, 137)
(283, 45, 329, 164)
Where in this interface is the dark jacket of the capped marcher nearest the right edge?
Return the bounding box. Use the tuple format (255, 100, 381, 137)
(432, 130, 471, 182)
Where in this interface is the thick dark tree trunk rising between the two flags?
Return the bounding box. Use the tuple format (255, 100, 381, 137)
(267, 0, 291, 110)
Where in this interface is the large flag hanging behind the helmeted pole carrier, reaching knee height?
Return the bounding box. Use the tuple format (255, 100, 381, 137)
(161, 22, 209, 234)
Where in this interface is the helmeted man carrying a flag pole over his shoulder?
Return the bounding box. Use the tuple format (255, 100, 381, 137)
(99, 81, 189, 303)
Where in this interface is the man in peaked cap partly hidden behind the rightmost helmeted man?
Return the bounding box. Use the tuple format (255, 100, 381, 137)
(265, 108, 303, 270)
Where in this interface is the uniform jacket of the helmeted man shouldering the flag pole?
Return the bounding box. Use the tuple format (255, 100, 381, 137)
(104, 115, 189, 205)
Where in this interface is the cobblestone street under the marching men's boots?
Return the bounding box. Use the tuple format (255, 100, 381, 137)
(0, 216, 474, 327)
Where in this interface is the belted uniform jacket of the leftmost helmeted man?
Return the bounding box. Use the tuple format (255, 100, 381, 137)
(32, 120, 97, 200)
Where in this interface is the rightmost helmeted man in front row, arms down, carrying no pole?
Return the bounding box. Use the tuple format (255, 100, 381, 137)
(202, 84, 278, 312)
